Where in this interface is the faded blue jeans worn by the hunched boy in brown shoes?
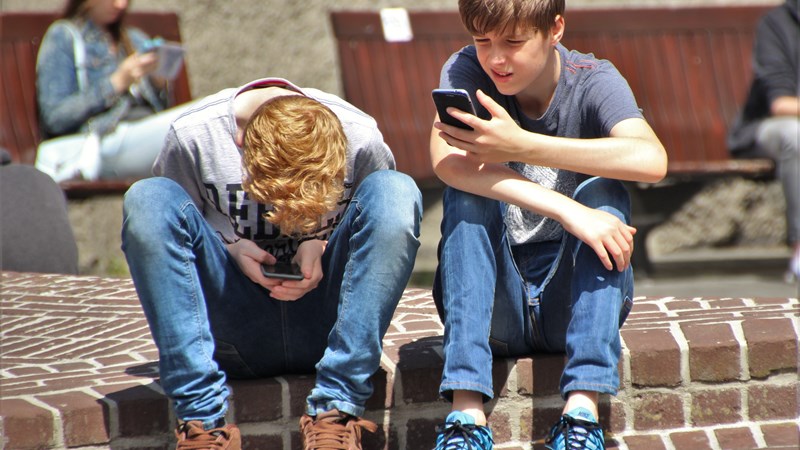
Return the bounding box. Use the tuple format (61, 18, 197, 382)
(122, 170, 422, 425)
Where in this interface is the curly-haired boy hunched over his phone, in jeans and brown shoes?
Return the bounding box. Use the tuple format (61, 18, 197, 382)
(122, 78, 422, 450)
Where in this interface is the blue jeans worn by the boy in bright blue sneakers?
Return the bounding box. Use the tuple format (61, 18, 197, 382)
(433, 178, 633, 399)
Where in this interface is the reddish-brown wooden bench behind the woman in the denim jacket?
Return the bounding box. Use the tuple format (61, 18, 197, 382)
(0, 11, 192, 198)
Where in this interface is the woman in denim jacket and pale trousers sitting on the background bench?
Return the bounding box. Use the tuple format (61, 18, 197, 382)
(36, 0, 193, 182)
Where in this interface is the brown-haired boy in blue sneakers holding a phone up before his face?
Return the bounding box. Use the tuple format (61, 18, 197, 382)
(431, 0, 667, 450)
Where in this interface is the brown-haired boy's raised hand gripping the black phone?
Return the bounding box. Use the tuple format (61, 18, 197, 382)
(434, 90, 527, 163)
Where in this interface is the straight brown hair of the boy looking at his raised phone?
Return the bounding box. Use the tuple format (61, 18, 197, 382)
(458, 0, 564, 36)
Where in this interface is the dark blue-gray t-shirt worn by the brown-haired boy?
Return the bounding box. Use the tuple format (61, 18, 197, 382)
(439, 44, 643, 244)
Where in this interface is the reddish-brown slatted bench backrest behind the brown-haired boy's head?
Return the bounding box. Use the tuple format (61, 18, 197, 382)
(331, 5, 771, 184)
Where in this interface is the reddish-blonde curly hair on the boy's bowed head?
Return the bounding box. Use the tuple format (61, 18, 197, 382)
(242, 95, 347, 236)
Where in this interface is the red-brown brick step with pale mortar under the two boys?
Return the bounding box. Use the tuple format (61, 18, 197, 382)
(0, 272, 800, 450)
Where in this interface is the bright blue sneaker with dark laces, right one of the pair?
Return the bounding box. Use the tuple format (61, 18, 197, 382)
(544, 407, 606, 450)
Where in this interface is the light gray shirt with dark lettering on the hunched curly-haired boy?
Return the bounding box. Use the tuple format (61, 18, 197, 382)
(153, 78, 395, 258)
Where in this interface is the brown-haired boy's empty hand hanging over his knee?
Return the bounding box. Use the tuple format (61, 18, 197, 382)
(562, 205, 636, 272)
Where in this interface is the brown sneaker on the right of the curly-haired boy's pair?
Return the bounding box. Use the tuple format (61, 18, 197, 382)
(300, 409, 378, 450)
